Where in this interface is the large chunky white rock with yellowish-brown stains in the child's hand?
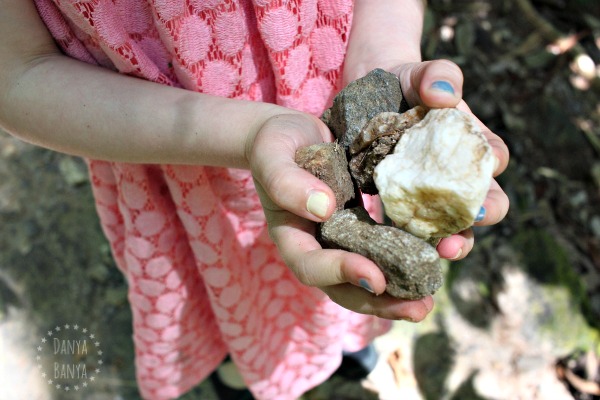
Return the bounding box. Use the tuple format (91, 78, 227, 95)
(374, 108, 495, 239)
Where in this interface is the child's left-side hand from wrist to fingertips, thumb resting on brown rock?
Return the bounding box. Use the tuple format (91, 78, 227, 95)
(247, 111, 433, 321)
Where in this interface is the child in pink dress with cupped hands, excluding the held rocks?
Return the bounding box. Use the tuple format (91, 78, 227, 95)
(0, 0, 508, 399)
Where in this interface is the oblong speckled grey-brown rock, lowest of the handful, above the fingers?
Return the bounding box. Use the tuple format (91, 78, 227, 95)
(318, 207, 443, 299)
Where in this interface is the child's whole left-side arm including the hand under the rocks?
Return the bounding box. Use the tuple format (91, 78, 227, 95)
(0, 0, 432, 320)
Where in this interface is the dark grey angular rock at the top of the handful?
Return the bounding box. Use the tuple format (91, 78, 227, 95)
(322, 69, 408, 148)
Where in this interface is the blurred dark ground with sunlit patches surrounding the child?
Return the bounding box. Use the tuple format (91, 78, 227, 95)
(0, 0, 600, 400)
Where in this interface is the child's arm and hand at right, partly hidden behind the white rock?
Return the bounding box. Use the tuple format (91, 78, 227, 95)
(344, 0, 509, 259)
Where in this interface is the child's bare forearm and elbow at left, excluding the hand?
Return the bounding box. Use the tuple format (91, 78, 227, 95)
(0, 0, 298, 168)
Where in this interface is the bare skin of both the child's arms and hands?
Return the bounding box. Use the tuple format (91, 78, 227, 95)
(0, 0, 509, 321)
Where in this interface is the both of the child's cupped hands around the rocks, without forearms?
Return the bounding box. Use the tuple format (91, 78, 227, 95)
(247, 60, 509, 321)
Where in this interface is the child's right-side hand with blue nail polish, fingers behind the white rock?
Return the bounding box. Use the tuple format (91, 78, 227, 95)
(388, 60, 509, 260)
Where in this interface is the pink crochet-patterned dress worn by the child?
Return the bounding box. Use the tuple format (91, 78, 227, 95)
(35, 0, 390, 400)
